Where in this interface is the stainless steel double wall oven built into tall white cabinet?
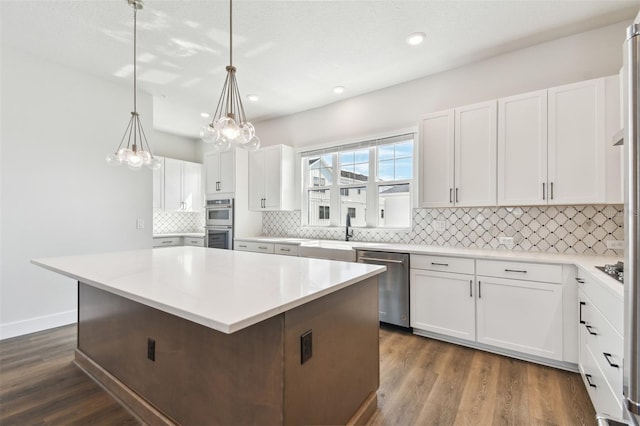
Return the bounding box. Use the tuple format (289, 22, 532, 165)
(205, 198, 234, 250)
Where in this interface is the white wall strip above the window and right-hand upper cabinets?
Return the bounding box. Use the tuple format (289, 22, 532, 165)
(255, 21, 630, 147)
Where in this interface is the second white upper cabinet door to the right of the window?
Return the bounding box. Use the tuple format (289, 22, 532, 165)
(453, 101, 498, 207)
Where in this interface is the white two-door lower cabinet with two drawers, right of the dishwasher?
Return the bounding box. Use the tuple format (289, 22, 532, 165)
(411, 255, 567, 363)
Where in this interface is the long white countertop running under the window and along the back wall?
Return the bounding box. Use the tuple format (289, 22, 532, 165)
(238, 237, 624, 297)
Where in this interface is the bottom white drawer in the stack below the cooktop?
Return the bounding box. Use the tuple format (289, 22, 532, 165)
(580, 340, 622, 417)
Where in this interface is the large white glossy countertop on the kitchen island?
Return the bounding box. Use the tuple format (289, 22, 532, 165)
(31, 247, 385, 333)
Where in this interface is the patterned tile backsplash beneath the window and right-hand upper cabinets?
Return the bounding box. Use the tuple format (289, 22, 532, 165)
(262, 205, 624, 255)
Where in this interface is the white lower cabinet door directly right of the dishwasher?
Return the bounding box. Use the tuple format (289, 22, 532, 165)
(410, 269, 476, 340)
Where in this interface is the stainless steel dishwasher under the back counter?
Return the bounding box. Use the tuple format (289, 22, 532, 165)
(356, 250, 409, 327)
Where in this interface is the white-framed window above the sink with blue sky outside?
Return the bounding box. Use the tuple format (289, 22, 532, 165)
(302, 134, 414, 228)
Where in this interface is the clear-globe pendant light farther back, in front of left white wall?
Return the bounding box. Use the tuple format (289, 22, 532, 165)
(107, 0, 162, 170)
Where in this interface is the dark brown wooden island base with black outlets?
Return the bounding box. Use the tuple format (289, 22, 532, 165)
(76, 276, 379, 425)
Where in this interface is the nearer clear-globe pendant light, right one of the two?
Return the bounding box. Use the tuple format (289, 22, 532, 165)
(200, 0, 260, 151)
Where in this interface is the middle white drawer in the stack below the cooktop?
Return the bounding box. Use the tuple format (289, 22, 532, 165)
(578, 291, 624, 395)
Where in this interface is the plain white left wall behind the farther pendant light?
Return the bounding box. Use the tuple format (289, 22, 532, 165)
(0, 45, 200, 338)
